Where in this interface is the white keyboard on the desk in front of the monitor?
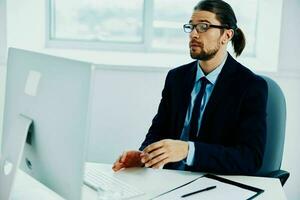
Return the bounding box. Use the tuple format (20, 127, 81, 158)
(84, 167, 144, 199)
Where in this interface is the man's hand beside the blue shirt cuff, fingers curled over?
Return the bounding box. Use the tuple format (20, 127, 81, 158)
(141, 139, 189, 168)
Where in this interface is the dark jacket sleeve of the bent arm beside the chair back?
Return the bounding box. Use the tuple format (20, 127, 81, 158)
(190, 78, 268, 174)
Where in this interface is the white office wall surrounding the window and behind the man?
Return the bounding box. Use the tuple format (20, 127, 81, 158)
(0, 0, 300, 200)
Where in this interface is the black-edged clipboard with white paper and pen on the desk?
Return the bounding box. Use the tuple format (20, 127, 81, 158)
(152, 174, 264, 200)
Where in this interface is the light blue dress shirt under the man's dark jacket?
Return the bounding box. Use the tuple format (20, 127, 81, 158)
(180, 54, 228, 166)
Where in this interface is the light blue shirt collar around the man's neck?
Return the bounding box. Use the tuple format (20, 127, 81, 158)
(195, 53, 228, 85)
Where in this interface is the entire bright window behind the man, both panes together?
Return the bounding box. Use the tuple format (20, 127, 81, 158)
(49, 0, 257, 54)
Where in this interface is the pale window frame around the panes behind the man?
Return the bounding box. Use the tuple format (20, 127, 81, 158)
(45, 0, 283, 72)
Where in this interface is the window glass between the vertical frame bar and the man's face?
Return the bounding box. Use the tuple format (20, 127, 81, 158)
(151, 0, 198, 51)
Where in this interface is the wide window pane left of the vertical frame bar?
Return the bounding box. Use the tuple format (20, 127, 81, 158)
(50, 0, 143, 43)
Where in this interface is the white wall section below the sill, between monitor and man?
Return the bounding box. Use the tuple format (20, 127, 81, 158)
(88, 65, 167, 163)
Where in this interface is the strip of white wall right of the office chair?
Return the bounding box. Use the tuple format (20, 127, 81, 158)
(275, 0, 300, 200)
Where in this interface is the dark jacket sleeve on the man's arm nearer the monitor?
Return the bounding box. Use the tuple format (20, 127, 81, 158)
(139, 71, 171, 151)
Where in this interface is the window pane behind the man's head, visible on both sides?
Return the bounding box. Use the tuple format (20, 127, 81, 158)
(152, 0, 258, 54)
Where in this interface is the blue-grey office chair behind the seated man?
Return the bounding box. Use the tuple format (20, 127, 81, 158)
(257, 76, 290, 186)
